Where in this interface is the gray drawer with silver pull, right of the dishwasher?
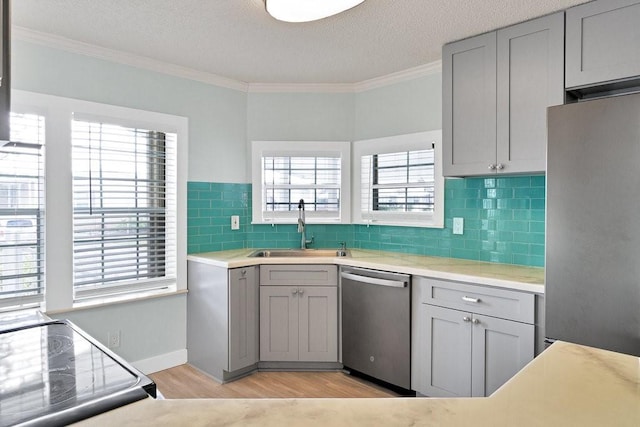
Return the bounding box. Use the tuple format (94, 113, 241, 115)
(420, 279, 535, 323)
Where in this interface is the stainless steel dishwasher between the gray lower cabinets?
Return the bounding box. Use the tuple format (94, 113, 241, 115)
(340, 267, 411, 390)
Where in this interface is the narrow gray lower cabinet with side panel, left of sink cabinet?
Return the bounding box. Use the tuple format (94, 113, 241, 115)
(187, 261, 259, 382)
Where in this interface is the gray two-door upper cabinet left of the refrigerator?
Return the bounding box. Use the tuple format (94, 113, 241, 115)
(442, 12, 564, 176)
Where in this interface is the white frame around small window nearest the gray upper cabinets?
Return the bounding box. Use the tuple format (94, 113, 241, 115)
(351, 130, 444, 228)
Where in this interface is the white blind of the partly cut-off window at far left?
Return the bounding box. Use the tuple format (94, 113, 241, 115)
(0, 113, 45, 308)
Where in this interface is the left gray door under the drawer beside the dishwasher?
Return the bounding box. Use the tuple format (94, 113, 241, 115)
(416, 304, 472, 397)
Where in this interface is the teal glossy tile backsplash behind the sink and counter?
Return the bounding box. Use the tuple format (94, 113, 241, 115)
(187, 175, 545, 266)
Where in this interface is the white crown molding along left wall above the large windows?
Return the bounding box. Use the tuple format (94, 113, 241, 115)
(11, 26, 247, 92)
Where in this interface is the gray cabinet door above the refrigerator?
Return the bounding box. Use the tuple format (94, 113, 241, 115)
(566, 0, 640, 88)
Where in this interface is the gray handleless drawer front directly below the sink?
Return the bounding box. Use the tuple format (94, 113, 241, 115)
(260, 264, 338, 286)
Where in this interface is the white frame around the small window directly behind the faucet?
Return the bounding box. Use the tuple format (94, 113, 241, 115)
(251, 141, 351, 224)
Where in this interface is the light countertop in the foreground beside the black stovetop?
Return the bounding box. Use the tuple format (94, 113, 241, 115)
(78, 342, 640, 427)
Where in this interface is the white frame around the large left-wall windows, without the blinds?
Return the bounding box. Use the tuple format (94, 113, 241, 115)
(12, 90, 189, 313)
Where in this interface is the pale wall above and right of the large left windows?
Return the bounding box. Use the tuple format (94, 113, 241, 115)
(11, 40, 247, 183)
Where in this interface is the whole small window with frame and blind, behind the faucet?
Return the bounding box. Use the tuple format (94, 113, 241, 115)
(252, 141, 350, 223)
